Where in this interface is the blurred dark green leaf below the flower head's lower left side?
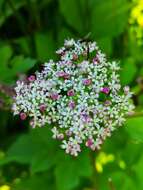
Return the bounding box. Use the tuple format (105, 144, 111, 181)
(1, 127, 57, 173)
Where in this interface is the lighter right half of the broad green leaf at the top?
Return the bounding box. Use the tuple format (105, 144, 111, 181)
(90, 0, 128, 38)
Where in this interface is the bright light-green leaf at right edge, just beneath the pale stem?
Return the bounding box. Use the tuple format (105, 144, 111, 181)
(125, 117, 143, 143)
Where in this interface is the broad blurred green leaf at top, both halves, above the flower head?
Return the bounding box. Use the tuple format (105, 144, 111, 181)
(59, 0, 128, 38)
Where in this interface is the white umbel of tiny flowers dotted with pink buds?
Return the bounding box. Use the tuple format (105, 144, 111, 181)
(13, 39, 134, 156)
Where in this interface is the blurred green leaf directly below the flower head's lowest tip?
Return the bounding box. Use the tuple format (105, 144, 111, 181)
(55, 153, 92, 190)
